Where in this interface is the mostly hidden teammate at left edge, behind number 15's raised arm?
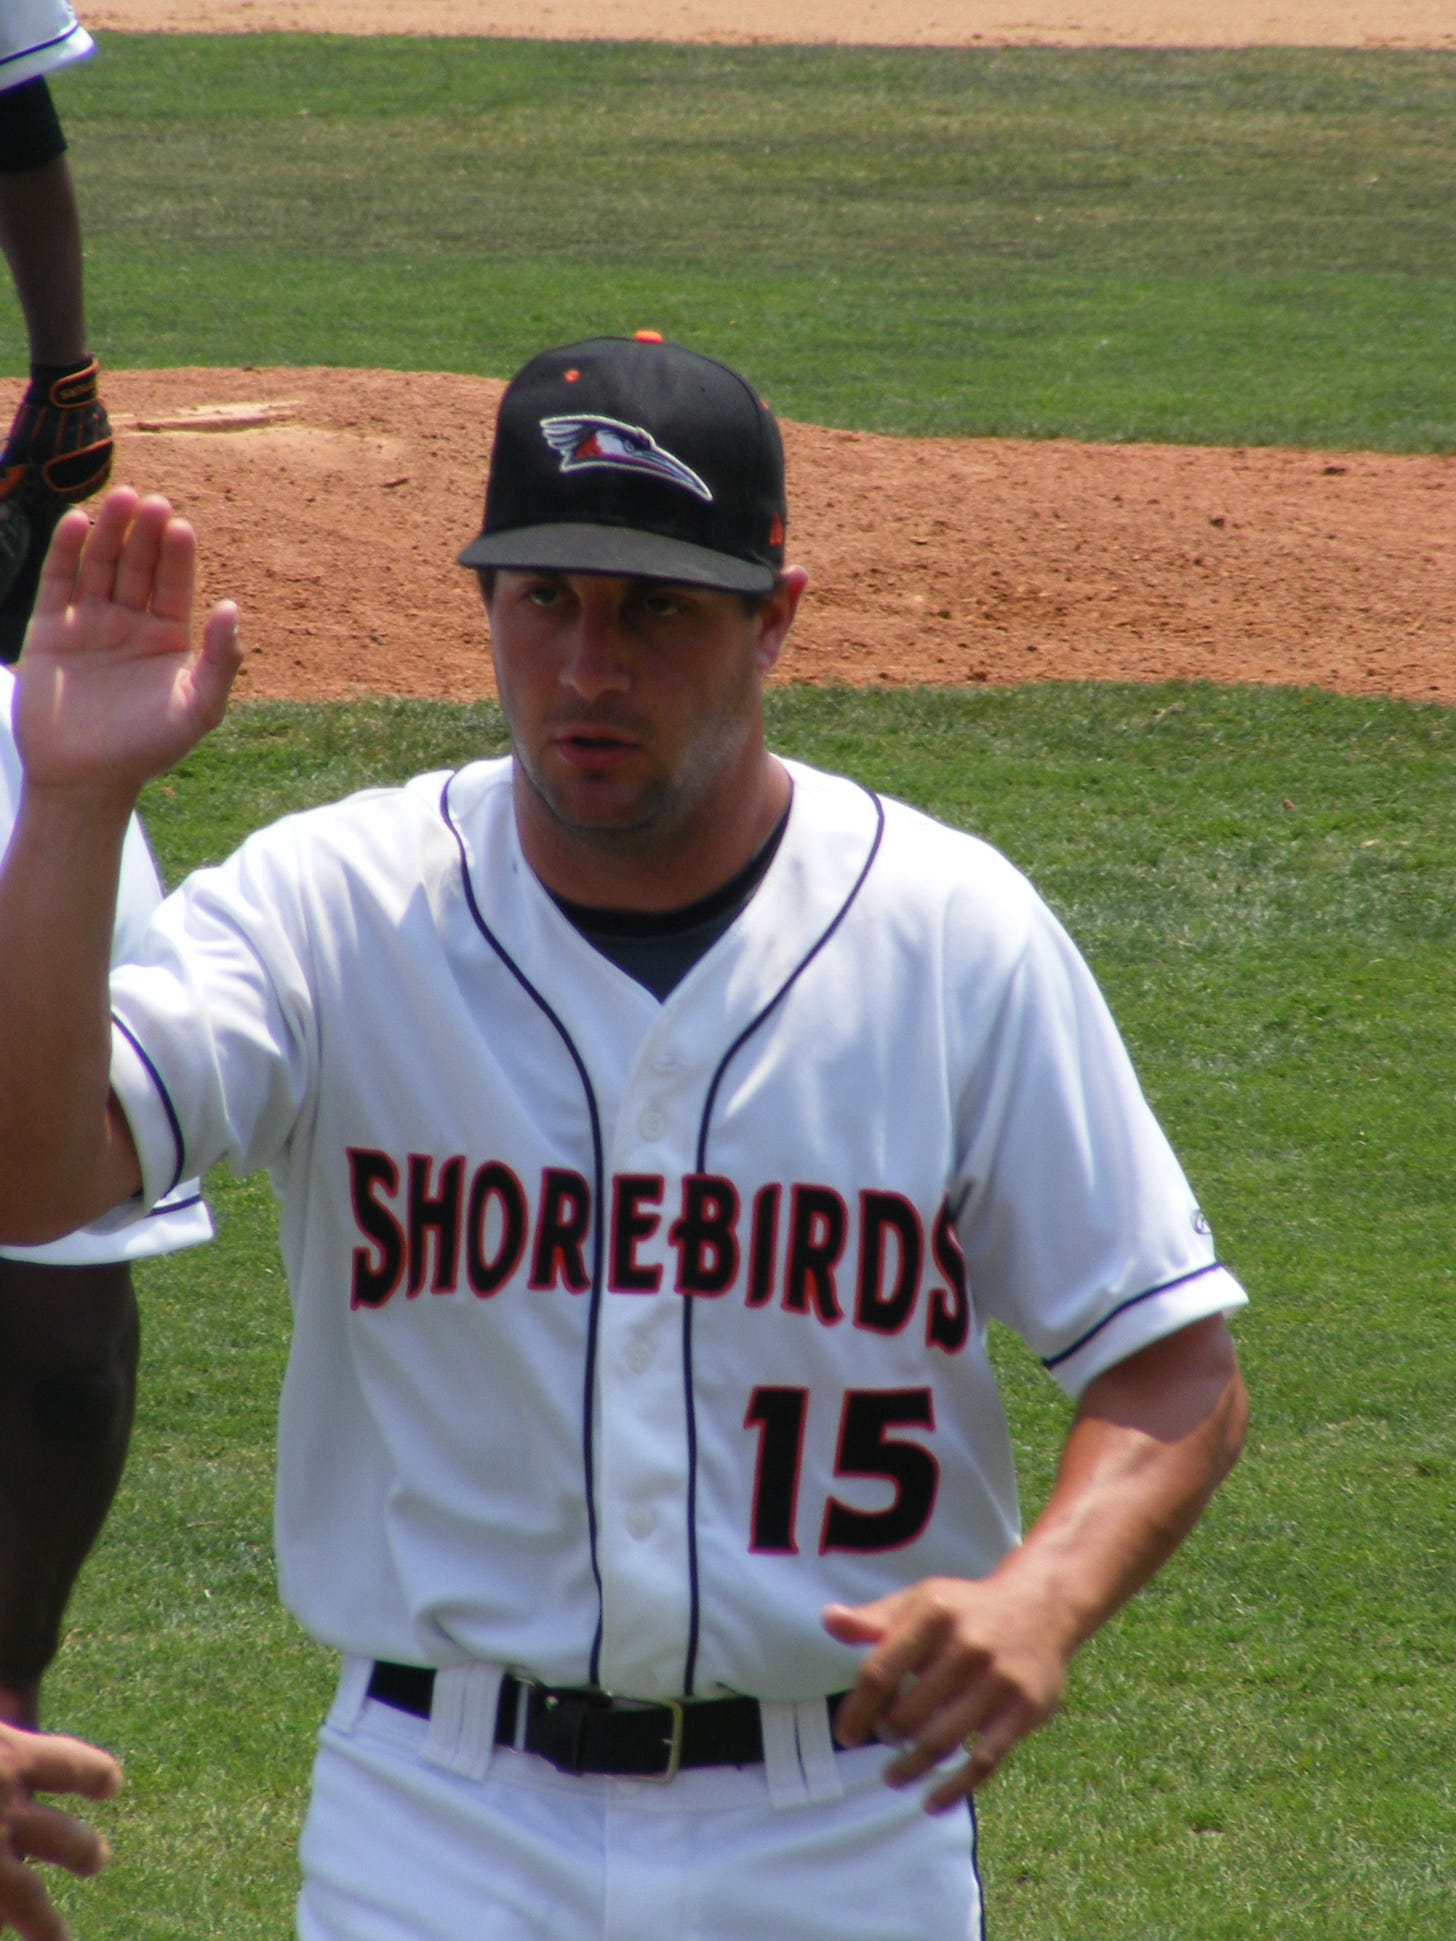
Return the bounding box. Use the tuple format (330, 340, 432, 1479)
(0, 668, 212, 1941)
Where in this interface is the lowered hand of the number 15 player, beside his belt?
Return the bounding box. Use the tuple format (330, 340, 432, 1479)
(823, 1576, 1072, 1813)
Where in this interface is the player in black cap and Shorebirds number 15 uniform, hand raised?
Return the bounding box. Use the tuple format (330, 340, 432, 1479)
(0, 336, 1244, 1941)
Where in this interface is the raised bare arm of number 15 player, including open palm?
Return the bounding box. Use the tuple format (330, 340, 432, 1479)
(0, 487, 241, 1244)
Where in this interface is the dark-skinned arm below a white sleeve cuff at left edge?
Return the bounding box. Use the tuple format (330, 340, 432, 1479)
(0, 1260, 138, 1726)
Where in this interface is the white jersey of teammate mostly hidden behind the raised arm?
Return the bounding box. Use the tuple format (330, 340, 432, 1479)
(0, 668, 212, 1267)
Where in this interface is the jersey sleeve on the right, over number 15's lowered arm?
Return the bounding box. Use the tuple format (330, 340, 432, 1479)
(957, 885, 1246, 1396)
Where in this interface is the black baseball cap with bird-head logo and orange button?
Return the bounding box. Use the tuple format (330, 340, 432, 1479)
(460, 330, 786, 594)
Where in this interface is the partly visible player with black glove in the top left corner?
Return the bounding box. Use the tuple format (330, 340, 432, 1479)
(0, 0, 113, 662)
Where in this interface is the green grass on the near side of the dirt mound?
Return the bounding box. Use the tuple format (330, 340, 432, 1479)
(50, 683, 1456, 1941)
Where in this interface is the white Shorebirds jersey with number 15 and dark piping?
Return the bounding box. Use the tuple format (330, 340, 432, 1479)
(113, 761, 1244, 1698)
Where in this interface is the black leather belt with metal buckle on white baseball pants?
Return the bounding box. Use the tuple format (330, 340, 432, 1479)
(369, 1660, 839, 1780)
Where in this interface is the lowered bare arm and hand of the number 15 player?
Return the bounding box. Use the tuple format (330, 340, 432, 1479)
(825, 1318, 1246, 1813)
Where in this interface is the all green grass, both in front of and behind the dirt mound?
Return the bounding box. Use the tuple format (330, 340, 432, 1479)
(19, 37, 1456, 1941)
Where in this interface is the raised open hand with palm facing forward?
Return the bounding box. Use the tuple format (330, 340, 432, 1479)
(16, 485, 243, 798)
